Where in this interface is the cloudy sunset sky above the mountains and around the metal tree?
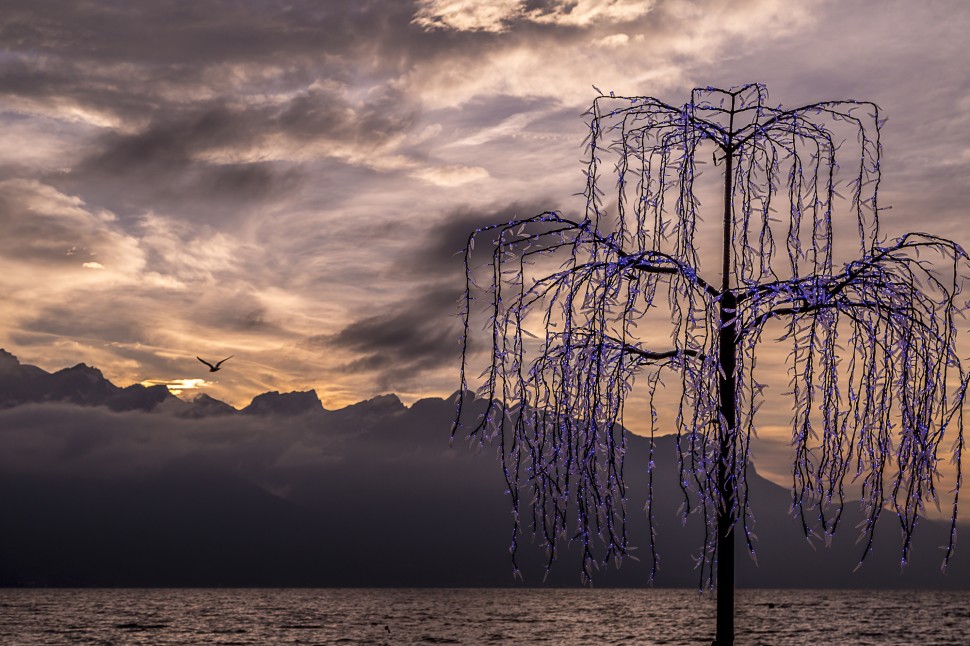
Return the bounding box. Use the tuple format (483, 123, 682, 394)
(0, 0, 970, 416)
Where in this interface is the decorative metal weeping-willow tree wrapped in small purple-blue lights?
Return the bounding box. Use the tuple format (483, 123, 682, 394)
(455, 85, 968, 644)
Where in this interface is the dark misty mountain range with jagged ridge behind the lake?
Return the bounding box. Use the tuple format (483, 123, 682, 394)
(0, 351, 970, 588)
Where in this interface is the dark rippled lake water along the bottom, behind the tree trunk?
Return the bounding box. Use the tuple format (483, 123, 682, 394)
(0, 589, 970, 646)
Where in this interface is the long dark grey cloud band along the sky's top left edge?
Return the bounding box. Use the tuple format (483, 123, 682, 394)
(0, 0, 500, 109)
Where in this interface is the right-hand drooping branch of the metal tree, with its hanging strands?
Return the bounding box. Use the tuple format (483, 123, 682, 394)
(739, 234, 968, 561)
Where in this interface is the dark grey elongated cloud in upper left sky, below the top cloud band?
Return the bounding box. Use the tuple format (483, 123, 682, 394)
(49, 83, 413, 221)
